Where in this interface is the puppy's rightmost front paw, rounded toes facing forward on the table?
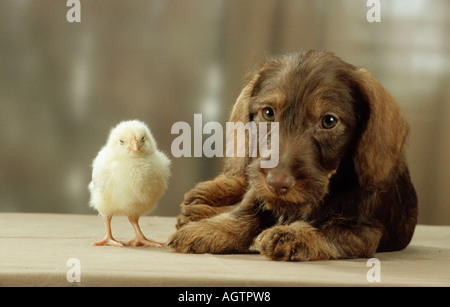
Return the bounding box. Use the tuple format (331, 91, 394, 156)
(255, 225, 333, 261)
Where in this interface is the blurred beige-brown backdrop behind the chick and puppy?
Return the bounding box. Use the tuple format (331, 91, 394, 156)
(0, 0, 450, 225)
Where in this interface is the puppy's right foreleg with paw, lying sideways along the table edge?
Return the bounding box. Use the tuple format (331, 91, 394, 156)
(255, 221, 382, 261)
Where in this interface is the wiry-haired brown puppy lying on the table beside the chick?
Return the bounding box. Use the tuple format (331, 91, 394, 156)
(169, 51, 417, 260)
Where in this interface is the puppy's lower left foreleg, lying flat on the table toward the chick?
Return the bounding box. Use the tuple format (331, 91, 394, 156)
(168, 199, 261, 254)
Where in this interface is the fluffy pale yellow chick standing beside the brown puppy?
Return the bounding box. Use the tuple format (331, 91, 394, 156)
(89, 120, 170, 246)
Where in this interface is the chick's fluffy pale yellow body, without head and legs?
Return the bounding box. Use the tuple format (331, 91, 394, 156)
(89, 121, 170, 217)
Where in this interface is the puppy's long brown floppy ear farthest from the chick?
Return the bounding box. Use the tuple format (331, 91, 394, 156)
(354, 68, 408, 190)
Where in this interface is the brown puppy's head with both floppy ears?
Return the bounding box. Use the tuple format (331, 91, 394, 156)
(225, 51, 407, 212)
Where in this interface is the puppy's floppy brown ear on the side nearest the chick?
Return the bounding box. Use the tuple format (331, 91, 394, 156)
(224, 72, 261, 177)
